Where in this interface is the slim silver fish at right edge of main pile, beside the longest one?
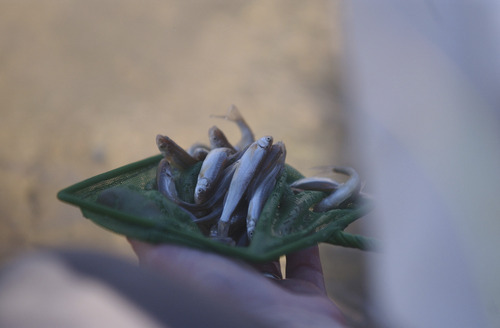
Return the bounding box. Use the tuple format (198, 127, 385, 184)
(246, 142, 286, 239)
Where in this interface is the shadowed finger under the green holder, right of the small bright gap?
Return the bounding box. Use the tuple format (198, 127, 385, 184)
(286, 245, 326, 294)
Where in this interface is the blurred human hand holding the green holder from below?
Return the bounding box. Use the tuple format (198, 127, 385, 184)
(129, 240, 344, 327)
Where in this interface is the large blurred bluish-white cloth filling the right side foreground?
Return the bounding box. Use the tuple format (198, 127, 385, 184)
(343, 0, 500, 327)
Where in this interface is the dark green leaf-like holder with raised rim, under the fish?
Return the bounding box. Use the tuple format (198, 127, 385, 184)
(57, 155, 374, 262)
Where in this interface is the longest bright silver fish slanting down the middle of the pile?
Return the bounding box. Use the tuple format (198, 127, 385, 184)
(218, 136, 273, 237)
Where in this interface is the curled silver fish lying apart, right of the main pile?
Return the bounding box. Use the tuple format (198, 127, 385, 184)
(314, 166, 361, 212)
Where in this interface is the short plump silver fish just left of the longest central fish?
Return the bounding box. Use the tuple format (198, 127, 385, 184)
(194, 148, 233, 204)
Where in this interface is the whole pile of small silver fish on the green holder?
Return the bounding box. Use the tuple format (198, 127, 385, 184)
(156, 105, 360, 246)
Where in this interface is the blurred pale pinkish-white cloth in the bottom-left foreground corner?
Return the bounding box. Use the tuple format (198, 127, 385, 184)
(0, 253, 166, 328)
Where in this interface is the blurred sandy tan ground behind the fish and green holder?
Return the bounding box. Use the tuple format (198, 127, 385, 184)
(0, 0, 376, 326)
